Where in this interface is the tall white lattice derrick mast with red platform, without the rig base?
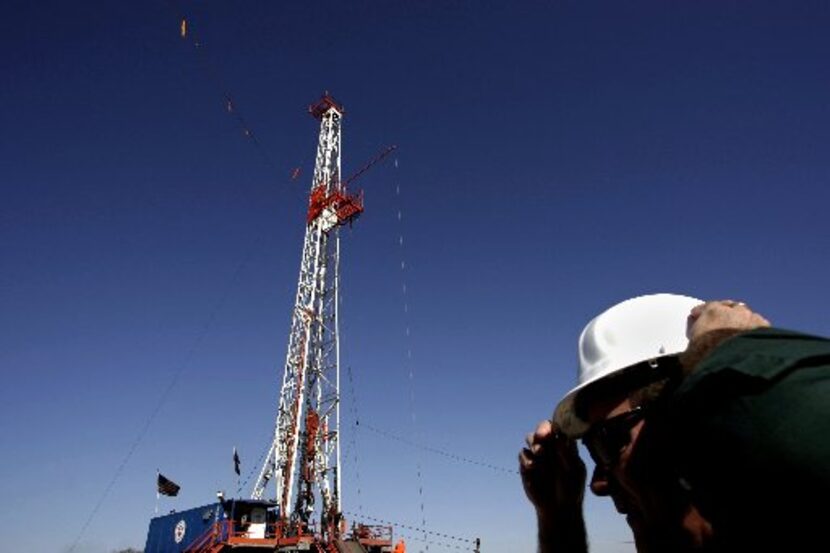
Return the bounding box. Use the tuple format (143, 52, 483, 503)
(251, 93, 363, 541)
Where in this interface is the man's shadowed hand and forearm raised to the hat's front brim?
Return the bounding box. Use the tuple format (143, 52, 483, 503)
(519, 421, 588, 553)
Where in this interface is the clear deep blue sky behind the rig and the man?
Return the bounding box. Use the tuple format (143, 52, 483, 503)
(0, 0, 830, 553)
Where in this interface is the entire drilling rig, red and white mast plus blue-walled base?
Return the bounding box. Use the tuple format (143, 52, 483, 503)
(144, 93, 400, 553)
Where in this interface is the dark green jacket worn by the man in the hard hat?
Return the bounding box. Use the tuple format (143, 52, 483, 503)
(668, 329, 830, 551)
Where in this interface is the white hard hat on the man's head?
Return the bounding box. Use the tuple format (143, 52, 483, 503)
(553, 294, 703, 437)
